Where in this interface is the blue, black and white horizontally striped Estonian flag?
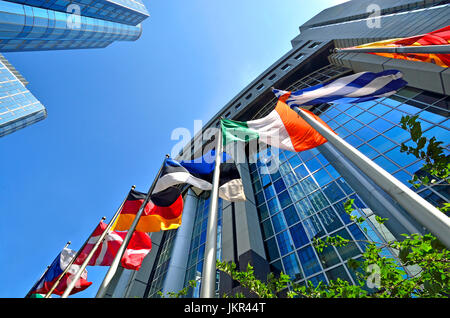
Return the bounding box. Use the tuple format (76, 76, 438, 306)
(154, 150, 245, 201)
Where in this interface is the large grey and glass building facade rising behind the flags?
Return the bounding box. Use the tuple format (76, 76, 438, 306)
(107, 0, 450, 298)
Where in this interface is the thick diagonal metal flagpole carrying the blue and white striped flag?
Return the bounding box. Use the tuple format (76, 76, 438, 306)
(295, 107, 450, 248)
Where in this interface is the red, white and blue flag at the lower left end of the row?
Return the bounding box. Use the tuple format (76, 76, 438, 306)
(30, 247, 92, 295)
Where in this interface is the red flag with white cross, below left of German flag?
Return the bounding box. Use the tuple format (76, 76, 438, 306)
(75, 222, 152, 270)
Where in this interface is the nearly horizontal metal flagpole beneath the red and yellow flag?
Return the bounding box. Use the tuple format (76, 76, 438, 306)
(334, 45, 450, 54)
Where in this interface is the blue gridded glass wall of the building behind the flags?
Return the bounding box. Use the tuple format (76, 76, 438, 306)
(250, 83, 450, 283)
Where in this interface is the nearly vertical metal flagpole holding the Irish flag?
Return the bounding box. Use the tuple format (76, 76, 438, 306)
(200, 129, 222, 298)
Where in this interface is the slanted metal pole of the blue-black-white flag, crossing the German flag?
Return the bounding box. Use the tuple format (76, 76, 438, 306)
(95, 155, 169, 298)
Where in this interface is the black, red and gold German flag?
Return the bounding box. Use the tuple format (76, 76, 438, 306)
(112, 186, 183, 232)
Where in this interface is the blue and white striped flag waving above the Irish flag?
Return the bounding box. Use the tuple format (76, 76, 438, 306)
(273, 70, 408, 108)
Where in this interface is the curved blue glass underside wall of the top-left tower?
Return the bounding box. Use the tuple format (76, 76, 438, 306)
(0, 1, 142, 52)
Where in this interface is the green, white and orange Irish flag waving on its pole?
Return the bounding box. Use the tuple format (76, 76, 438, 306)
(221, 95, 331, 152)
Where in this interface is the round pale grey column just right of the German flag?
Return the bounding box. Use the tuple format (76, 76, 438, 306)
(162, 189, 198, 294)
